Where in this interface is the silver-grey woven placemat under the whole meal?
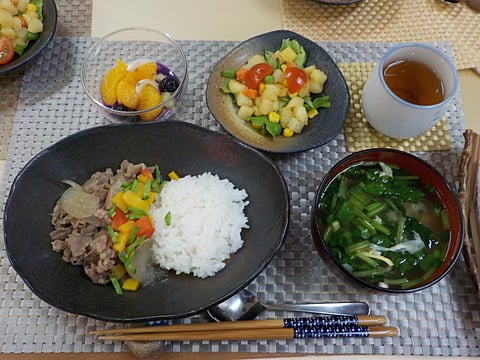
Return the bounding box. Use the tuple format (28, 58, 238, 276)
(0, 38, 480, 358)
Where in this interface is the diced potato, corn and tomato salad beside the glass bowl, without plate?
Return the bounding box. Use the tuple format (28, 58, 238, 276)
(221, 39, 330, 137)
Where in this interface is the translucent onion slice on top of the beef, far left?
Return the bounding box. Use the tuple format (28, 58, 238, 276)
(59, 180, 100, 219)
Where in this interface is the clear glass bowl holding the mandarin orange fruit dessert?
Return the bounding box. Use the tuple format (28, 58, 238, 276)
(81, 27, 188, 122)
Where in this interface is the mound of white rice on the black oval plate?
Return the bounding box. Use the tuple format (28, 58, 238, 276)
(151, 173, 248, 278)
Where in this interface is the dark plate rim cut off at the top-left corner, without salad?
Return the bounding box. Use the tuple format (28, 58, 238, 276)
(0, 0, 57, 75)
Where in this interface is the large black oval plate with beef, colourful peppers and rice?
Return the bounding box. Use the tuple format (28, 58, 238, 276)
(4, 121, 289, 322)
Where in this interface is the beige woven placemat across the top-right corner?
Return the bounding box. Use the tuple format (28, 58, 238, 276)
(281, 0, 480, 69)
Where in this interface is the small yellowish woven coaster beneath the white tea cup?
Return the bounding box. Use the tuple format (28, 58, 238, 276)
(338, 62, 453, 152)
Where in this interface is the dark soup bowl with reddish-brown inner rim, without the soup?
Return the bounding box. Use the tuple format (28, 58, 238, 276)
(311, 148, 465, 293)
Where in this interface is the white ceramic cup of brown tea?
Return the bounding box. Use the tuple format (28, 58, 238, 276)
(362, 43, 458, 139)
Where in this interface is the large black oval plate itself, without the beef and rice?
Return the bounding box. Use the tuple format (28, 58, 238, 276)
(4, 121, 290, 322)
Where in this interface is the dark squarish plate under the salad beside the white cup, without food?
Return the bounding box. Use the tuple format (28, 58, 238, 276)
(207, 30, 350, 153)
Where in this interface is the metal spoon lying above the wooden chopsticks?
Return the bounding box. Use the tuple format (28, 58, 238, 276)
(207, 289, 370, 321)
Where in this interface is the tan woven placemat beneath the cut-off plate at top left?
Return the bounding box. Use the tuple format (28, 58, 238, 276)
(0, 0, 92, 160)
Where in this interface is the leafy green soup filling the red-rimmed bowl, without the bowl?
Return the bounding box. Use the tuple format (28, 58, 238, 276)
(318, 162, 450, 289)
